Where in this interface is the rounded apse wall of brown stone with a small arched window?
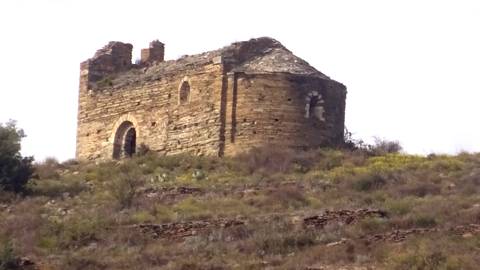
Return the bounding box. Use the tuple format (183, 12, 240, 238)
(225, 73, 346, 155)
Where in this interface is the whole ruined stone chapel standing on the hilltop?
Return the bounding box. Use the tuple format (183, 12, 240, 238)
(76, 37, 346, 160)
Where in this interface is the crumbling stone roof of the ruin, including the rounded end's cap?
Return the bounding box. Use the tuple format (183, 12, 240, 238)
(95, 37, 330, 86)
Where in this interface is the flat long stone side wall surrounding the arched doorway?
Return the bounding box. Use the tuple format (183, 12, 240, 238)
(77, 59, 222, 159)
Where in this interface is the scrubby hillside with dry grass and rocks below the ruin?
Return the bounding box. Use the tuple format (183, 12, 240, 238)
(0, 147, 480, 270)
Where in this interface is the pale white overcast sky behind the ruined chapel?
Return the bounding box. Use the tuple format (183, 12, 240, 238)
(0, 0, 480, 160)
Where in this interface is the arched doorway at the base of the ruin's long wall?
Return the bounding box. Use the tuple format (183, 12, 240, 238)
(113, 121, 137, 159)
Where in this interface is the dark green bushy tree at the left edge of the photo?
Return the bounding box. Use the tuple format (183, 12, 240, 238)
(0, 120, 33, 192)
